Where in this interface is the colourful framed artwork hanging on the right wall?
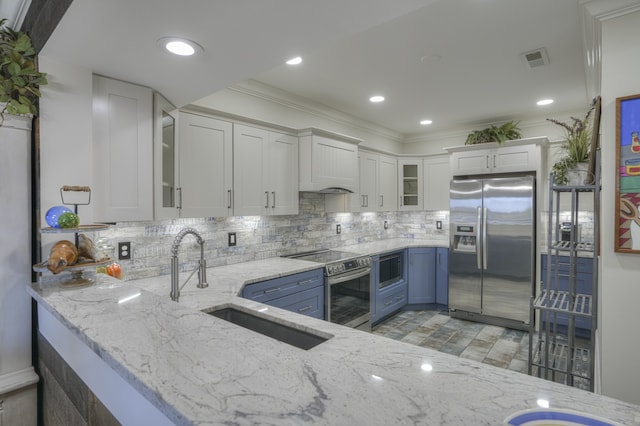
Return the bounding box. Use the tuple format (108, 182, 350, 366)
(614, 95, 640, 253)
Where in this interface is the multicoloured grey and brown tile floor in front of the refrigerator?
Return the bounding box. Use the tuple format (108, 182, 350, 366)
(373, 310, 589, 389)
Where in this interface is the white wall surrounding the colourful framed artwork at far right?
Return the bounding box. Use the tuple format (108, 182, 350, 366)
(599, 8, 640, 404)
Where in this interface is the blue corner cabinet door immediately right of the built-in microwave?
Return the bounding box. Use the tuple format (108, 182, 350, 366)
(407, 247, 436, 304)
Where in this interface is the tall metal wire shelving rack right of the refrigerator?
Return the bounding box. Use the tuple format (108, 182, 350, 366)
(528, 150, 600, 391)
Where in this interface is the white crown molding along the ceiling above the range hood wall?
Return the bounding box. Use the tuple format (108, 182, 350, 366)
(227, 80, 404, 143)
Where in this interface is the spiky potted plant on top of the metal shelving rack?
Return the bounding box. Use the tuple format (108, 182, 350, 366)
(547, 106, 594, 185)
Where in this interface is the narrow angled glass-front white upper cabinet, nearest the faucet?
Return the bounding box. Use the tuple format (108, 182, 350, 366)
(153, 93, 180, 219)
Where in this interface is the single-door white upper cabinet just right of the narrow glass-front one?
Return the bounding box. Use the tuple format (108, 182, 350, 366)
(178, 111, 233, 217)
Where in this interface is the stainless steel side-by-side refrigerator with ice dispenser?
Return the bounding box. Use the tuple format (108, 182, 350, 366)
(449, 175, 536, 329)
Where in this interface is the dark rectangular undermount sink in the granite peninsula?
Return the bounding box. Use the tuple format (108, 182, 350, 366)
(204, 307, 329, 350)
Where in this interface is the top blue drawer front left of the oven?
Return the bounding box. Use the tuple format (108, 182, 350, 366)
(242, 269, 324, 302)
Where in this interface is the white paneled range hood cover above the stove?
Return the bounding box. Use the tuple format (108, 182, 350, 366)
(299, 129, 361, 192)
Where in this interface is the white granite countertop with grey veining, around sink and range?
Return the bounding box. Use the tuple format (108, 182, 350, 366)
(29, 240, 640, 425)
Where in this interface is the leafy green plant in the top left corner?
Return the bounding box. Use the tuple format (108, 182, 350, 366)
(0, 19, 47, 126)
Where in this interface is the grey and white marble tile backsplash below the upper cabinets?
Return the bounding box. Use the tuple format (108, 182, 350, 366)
(99, 192, 449, 279)
